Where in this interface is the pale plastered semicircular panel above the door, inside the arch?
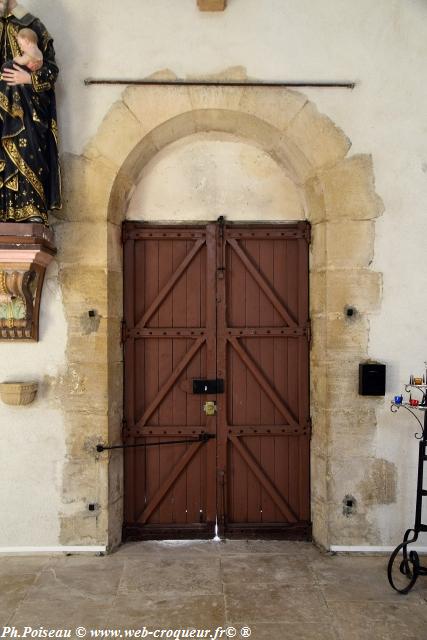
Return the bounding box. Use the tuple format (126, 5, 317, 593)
(126, 133, 305, 222)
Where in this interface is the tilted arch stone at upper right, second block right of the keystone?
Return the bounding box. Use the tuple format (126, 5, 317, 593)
(286, 102, 351, 168)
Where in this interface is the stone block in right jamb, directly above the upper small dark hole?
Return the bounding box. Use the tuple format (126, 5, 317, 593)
(326, 269, 382, 313)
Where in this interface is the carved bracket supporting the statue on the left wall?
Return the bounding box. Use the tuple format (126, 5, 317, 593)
(0, 222, 56, 341)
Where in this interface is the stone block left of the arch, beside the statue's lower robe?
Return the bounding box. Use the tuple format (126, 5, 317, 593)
(59, 153, 117, 223)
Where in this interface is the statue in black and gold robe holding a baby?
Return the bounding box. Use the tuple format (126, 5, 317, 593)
(0, 0, 61, 225)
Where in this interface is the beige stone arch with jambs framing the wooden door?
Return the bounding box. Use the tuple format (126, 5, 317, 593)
(57, 86, 382, 547)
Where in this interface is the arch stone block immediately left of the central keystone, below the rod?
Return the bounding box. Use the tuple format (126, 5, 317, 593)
(123, 86, 193, 135)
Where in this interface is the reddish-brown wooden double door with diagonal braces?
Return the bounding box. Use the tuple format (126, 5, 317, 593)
(124, 220, 310, 539)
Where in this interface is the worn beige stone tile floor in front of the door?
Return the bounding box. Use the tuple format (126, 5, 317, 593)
(0, 540, 427, 640)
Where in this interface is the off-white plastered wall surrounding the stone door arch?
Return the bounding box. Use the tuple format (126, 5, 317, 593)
(0, 0, 427, 546)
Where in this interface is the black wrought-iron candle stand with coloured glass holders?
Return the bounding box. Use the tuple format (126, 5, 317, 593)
(387, 376, 427, 594)
